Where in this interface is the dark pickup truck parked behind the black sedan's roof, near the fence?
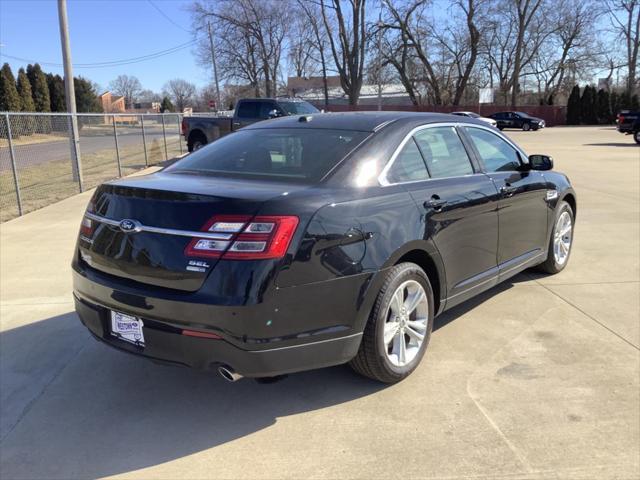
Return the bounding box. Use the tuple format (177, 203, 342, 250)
(182, 98, 320, 152)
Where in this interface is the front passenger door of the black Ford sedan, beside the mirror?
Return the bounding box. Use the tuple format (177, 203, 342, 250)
(464, 126, 548, 273)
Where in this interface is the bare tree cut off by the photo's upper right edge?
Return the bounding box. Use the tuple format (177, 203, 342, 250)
(606, 0, 640, 94)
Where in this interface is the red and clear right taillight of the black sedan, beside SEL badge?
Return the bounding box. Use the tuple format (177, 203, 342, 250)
(185, 215, 298, 260)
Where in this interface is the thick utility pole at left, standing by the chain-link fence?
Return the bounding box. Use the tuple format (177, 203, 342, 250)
(58, 0, 82, 192)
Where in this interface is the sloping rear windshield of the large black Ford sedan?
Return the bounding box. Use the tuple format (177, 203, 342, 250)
(165, 128, 369, 182)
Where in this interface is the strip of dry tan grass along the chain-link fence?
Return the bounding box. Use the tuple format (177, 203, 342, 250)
(0, 138, 180, 222)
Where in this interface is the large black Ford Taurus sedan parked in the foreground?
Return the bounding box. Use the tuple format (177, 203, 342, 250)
(73, 112, 576, 383)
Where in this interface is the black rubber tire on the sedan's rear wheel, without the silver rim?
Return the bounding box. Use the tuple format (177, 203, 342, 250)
(349, 262, 434, 383)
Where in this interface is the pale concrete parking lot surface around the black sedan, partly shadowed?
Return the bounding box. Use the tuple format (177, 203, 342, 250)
(0, 127, 640, 479)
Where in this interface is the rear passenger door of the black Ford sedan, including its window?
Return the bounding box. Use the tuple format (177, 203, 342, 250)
(387, 124, 498, 306)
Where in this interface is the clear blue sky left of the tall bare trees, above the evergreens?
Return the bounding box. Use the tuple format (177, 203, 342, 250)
(0, 0, 210, 91)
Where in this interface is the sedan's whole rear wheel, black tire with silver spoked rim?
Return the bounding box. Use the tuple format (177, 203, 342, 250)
(350, 262, 434, 383)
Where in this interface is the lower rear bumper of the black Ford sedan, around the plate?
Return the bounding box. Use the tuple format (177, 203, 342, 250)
(74, 295, 362, 377)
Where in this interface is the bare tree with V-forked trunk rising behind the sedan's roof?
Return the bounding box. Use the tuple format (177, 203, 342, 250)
(320, 0, 367, 105)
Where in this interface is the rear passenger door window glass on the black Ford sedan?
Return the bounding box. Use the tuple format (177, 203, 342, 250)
(414, 127, 473, 178)
